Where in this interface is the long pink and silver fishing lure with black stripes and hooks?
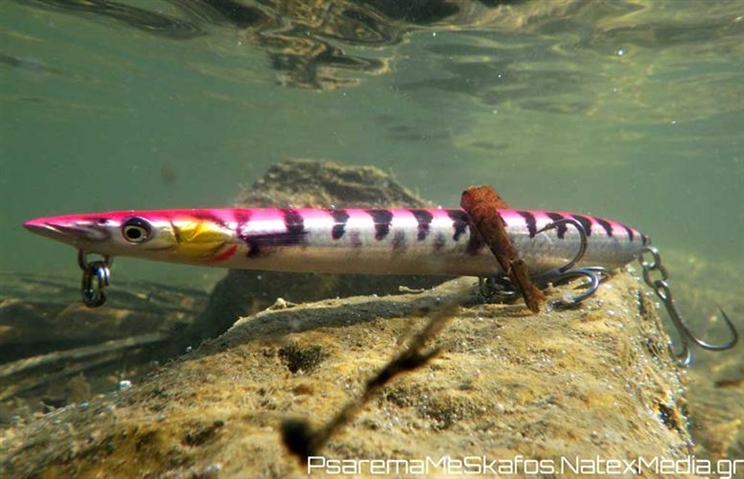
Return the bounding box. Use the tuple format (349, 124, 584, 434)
(23, 204, 738, 364)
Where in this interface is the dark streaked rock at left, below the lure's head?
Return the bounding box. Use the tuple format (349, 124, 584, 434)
(0, 272, 207, 408)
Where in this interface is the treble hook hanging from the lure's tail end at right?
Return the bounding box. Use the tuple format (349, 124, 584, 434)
(638, 245, 739, 366)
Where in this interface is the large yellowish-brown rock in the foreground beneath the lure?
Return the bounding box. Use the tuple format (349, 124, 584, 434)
(0, 273, 691, 478)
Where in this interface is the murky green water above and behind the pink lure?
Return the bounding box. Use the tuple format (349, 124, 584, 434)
(0, 0, 744, 330)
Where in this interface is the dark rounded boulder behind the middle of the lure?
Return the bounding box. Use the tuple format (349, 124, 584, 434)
(190, 160, 446, 344)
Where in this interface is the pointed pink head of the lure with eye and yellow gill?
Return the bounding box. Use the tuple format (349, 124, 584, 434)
(23, 210, 233, 262)
